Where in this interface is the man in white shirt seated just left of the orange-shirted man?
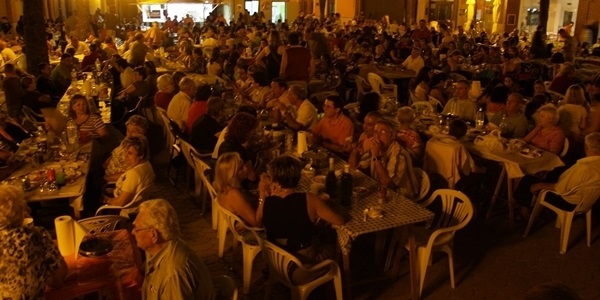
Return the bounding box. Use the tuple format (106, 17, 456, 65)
(280, 85, 317, 131)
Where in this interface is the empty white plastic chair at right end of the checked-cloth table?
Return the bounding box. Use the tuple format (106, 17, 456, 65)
(406, 189, 473, 295)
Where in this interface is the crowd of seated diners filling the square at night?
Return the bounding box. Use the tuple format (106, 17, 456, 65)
(0, 8, 600, 299)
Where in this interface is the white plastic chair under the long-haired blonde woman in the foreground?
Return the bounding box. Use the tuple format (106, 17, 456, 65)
(217, 205, 264, 294)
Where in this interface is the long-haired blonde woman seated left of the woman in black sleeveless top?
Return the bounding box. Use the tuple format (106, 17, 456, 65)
(214, 152, 261, 227)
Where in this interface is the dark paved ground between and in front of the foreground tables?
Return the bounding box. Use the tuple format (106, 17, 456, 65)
(150, 164, 600, 299)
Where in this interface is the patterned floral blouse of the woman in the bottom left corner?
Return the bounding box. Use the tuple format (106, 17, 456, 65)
(0, 227, 62, 300)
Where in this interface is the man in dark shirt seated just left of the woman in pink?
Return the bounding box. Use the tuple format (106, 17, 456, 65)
(490, 93, 529, 138)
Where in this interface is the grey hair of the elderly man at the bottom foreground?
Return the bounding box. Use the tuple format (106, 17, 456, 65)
(140, 199, 179, 241)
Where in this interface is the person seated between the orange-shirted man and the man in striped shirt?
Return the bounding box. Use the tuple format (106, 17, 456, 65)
(349, 111, 383, 170)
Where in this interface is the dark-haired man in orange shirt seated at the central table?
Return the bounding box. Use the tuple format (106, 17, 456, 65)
(312, 96, 354, 153)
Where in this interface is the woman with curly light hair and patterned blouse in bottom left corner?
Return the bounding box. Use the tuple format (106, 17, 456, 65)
(0, 185, 67, 299)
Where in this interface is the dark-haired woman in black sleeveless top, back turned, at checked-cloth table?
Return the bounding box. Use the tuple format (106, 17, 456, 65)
(258, 156, 345, 263)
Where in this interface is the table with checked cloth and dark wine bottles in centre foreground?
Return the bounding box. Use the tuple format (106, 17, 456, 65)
(300, 154, 434, 299)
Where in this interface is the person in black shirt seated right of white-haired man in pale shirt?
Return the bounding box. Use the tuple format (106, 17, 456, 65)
(190, 97, 225, 153)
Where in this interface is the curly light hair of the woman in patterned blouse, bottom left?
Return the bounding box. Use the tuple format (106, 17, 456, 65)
(0, 185, 27, 228)
